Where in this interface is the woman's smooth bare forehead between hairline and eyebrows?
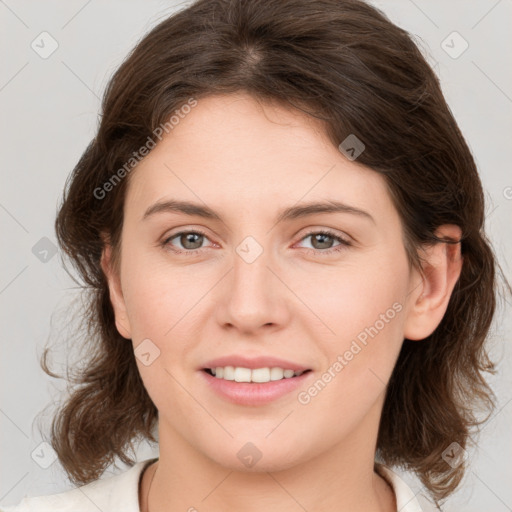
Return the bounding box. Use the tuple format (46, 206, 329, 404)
(127, 94, 391, 224)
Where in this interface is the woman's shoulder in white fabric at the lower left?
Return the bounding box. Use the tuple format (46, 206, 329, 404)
(0, 459, 156, 512)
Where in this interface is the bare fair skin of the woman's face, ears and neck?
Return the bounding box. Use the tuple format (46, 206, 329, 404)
(102, 93, 462, 512)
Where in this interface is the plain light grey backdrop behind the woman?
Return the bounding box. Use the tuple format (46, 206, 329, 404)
(0, 0, 512, 512)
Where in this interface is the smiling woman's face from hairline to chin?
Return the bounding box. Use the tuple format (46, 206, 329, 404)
(106, 94, 420, 470)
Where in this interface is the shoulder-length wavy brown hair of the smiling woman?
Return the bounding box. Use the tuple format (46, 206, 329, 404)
(42, 0, 508, 503)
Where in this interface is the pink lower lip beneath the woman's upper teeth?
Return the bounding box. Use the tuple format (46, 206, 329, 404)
(200, 370, 313, 405)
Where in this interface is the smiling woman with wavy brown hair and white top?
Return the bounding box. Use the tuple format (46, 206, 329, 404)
(3, 0, 504, 512)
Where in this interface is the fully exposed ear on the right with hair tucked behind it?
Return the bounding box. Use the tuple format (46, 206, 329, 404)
(404, 224, 463, 340)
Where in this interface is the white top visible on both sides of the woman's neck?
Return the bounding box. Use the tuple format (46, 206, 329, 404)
(0, 459, 433, 512)
